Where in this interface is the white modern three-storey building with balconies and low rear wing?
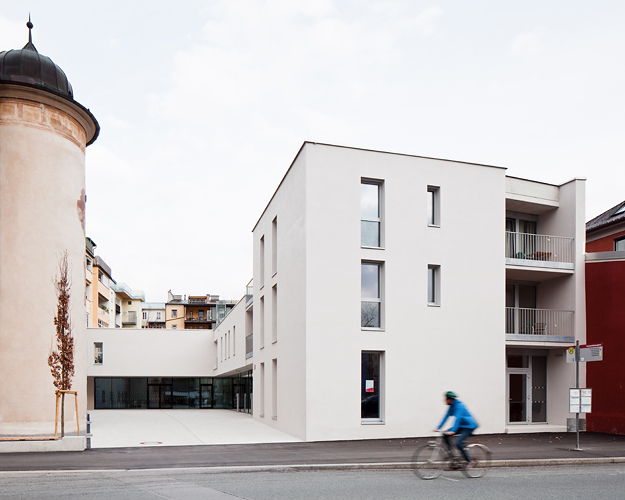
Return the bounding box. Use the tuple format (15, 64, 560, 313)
(88, 142, 585, 441)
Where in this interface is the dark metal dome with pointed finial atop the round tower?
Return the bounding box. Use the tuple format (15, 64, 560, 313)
(0, 16, 74, 99)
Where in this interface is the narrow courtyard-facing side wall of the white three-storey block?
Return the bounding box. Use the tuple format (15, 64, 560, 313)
(253, 147, 306, 439)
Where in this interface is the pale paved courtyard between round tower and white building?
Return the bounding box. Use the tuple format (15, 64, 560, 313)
(89, 410, 301, 448)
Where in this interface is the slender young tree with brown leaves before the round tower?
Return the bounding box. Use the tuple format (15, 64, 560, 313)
(48, 250, 74, 437)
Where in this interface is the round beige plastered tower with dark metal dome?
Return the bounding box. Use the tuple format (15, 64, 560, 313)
(0, 22, 99, 434)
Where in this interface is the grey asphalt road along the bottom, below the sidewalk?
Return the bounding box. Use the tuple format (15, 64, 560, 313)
(0, 465, 625, 500)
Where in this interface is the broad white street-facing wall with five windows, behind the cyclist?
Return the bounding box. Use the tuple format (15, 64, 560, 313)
(306, 145, 505, 440)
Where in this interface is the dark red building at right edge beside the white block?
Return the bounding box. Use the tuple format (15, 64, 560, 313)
(586, 201, 625, 434)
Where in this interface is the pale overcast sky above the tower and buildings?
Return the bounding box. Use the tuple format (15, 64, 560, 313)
(0, 0, 625, 302)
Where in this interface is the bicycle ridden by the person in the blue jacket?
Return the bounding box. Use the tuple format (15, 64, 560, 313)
(412, 434, 492, 479)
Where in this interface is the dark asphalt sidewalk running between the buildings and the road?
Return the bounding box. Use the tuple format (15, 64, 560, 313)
(0, 433, 625, 472)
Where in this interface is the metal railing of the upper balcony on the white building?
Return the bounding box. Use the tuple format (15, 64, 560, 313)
(506, 231, 575, 264)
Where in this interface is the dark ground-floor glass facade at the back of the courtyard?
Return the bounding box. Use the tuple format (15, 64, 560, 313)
(94, 372, 252, 413)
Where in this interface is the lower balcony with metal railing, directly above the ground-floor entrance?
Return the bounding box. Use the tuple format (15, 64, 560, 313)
(506, 307, 575, 343)
